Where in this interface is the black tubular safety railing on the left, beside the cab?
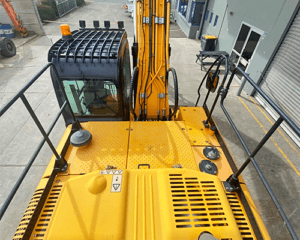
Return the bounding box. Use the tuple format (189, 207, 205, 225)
(0, 63, 77, 220)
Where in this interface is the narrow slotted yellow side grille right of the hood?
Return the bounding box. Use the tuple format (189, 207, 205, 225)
(226, 193, 256, 240)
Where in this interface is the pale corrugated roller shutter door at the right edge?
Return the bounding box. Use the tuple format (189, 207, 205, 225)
(255, 7, 300, 145)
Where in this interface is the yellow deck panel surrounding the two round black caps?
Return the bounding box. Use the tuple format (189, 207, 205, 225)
(192, 146, 233, 181)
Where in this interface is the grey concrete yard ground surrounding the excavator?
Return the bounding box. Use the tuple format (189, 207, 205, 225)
(0, 0, 300, 240)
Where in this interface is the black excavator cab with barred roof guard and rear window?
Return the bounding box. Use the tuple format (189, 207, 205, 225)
(48, 21, 131, 125)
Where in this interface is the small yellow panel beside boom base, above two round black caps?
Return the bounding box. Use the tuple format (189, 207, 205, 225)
(179, 107, 220, 146)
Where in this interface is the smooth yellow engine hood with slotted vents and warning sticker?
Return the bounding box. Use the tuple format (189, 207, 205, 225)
(40, 169, 241, 240)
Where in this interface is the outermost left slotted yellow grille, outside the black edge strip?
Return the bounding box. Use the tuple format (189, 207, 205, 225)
(13, 189, 44, 240)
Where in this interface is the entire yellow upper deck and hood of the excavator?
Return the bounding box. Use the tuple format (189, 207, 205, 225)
(14, 108, 268, 240)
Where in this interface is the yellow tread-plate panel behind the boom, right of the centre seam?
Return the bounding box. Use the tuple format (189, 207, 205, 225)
(127, 121, 197, 170)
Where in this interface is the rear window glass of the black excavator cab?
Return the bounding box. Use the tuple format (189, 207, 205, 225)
(63, 79, 120, 117)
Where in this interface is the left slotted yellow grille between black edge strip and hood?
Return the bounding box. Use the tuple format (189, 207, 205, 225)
(30, 185, 62, 240)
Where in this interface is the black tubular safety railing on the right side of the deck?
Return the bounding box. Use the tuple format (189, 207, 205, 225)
(220, 67, 300, 239)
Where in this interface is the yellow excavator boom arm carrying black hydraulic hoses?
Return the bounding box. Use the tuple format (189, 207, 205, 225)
(135, 0, 171, 120)
